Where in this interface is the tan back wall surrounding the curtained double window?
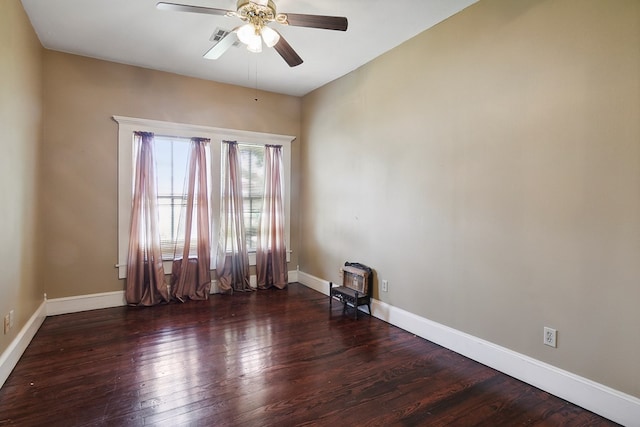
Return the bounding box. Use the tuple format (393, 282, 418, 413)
(40, 51, 301, 298)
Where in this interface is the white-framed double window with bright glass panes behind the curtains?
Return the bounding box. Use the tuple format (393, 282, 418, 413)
(113, 116, 295, 278)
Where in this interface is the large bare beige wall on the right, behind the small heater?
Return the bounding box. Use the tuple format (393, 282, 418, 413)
(300, 0, 640, 397)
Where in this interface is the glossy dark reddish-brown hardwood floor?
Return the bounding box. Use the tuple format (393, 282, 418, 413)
(0, 284, 615, 427)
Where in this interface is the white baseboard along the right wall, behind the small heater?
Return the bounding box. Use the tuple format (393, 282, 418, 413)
(298, 272, 640, 426)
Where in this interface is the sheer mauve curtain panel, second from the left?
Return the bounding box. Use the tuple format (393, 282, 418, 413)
(171, 138, 211, 302)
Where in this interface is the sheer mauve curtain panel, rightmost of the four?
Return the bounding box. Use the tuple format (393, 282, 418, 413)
(256, 145, 289, 289)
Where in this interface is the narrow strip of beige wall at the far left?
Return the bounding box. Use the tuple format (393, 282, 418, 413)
(0, 0, 44, 354)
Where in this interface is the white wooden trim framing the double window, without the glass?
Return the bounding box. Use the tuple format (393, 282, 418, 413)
(113, 116, 296, 279)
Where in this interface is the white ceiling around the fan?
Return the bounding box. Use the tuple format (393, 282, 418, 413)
(22, 0, 477, 96)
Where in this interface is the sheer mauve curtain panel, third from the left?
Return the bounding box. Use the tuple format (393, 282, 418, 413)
(216, 141, 251, 293)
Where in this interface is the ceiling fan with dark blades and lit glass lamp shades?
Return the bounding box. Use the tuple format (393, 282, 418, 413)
(156, 0, 348, 67)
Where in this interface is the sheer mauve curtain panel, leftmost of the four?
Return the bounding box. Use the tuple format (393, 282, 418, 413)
(125, 132, 169, 306)
